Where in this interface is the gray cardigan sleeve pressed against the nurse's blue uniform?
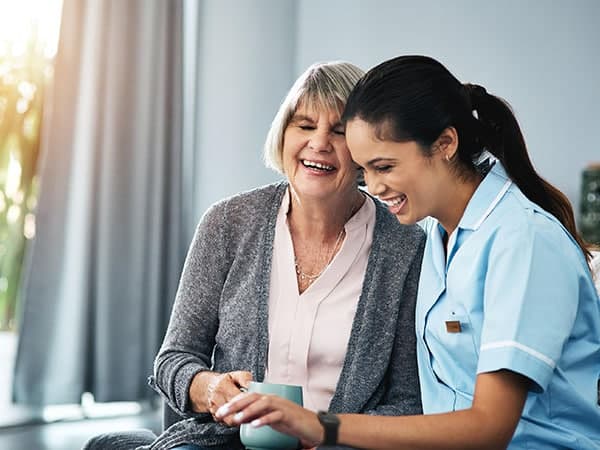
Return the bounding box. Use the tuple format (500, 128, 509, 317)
(364, 233, 425, 416)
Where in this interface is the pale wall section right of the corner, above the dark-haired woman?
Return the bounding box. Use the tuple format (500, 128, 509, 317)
(296, 0, 600, 210)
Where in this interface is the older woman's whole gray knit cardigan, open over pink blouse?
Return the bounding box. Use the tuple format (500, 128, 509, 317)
(143, 182, 425, 449)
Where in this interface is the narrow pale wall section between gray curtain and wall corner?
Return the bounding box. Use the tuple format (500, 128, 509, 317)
(186, 0, 295, 223)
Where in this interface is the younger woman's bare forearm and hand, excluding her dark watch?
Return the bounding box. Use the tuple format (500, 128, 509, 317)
(217, 393, 510, 450)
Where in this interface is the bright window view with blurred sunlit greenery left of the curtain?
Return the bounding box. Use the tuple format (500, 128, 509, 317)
(0, 0, 62, 331)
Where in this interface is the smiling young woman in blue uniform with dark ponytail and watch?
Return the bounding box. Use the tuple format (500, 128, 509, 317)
(221, 56, 600, 449)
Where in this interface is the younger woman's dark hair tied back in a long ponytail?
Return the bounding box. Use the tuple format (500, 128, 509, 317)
(342, 56, 591, 260)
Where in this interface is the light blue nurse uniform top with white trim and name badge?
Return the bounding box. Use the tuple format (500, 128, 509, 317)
(416, 162, 600, 449)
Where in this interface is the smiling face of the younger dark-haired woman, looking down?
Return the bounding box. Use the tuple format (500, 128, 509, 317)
(346, 119, 449, 224)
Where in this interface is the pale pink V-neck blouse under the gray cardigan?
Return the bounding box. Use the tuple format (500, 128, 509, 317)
(265, 191, 375, 411)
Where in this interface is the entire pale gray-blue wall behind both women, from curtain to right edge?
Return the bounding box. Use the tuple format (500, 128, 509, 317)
(191, 0, 600, 221)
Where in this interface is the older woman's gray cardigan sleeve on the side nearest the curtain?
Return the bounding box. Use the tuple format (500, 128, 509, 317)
(150, 204, 229, 415)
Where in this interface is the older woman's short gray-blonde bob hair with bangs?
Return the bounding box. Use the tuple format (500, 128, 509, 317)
(264, 61, 365, 173)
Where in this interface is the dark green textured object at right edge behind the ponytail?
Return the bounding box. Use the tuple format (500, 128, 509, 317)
(579, 163, 600, 245)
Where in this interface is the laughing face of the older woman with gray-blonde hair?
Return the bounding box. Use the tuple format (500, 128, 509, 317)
(283, 103, 357, 198)
